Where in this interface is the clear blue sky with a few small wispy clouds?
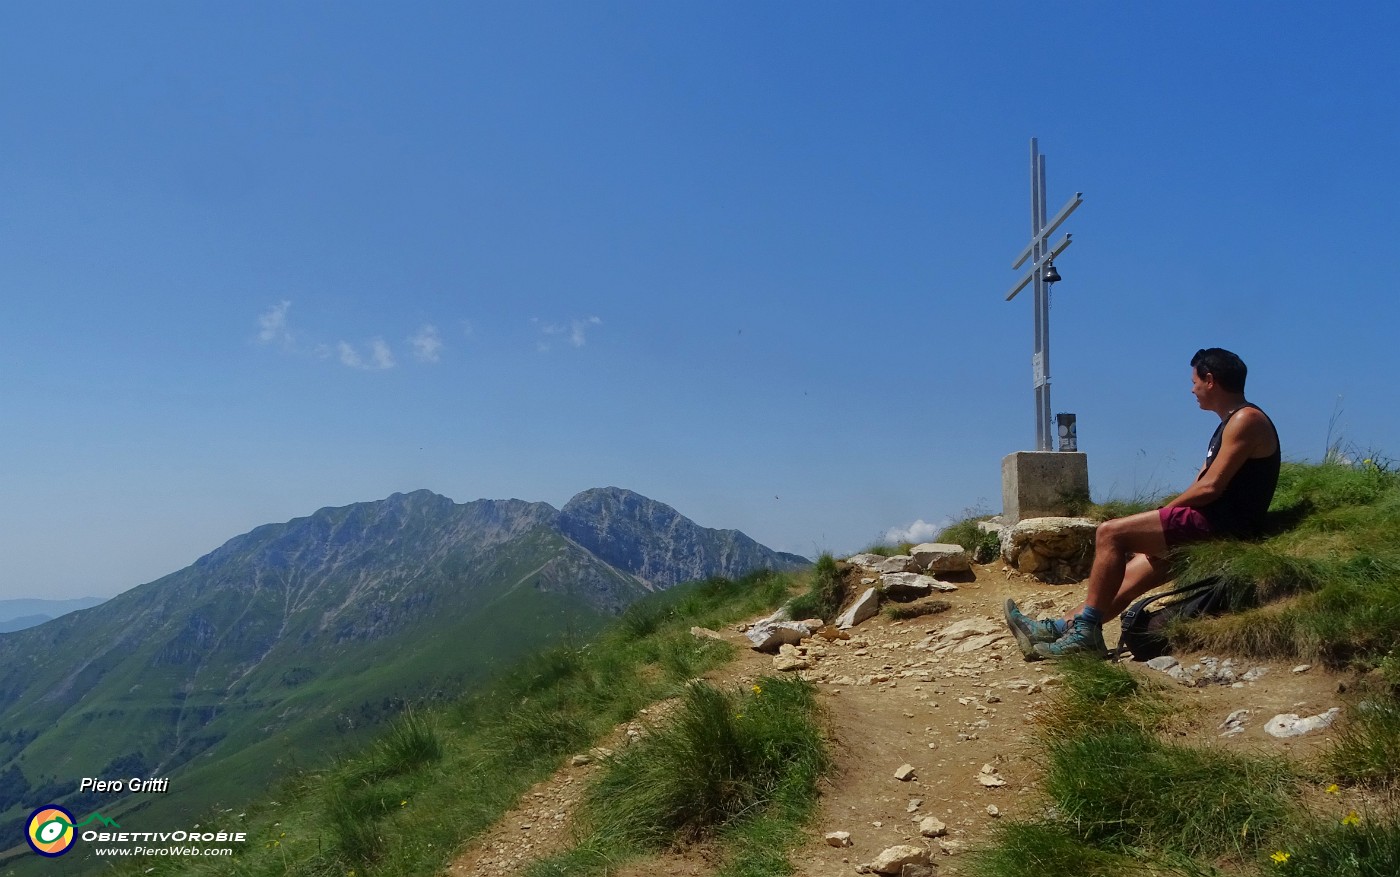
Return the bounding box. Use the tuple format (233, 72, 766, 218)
(0, 1, 1400, 598)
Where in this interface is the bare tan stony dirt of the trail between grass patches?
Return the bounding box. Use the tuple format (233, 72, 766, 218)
(448, 562, 1343, 877)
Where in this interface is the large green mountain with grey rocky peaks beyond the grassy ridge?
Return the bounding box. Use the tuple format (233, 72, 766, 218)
(0, 488, 806, 836)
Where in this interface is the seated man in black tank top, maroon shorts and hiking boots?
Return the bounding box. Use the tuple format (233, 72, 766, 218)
(1007, 347, 1280, 661)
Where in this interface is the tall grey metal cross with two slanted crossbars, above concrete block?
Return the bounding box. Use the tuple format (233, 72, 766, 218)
(1007, 137, 1084, 451)
